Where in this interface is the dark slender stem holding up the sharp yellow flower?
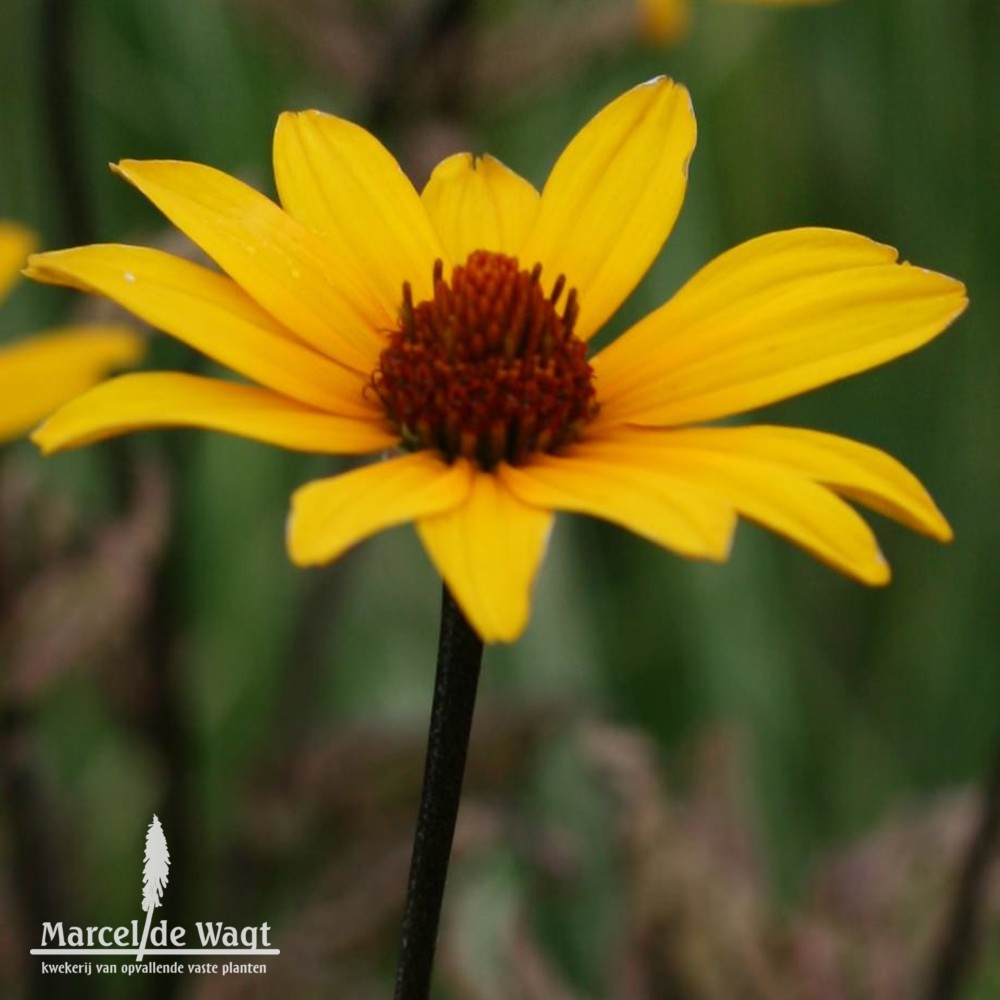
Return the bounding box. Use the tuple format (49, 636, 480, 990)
(395, 586, 483, 1000)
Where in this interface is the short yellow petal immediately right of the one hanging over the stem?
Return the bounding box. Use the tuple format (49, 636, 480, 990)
(499, 442, 736, 562)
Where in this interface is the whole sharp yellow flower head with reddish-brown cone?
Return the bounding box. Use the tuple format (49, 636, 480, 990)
(29, 78, 966, 642)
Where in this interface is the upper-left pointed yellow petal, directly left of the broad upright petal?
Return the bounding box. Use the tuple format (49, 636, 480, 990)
(114, 160, 386, 375)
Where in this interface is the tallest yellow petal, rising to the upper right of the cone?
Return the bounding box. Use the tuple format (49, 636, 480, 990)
(521, 77, 696, 339)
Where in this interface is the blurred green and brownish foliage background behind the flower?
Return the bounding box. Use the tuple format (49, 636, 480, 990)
(0, 0, 1000, 1000)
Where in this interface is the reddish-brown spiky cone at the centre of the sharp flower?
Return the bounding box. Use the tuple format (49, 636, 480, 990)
(371, 250, 598, 469)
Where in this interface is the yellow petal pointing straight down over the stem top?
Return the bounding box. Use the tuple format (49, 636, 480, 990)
(417, 472, 552, 642)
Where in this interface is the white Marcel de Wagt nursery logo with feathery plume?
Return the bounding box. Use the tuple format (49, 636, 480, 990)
(31, 814, 281, 975)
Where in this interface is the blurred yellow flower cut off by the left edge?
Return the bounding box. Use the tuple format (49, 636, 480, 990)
(0, 227, 143, 444)
